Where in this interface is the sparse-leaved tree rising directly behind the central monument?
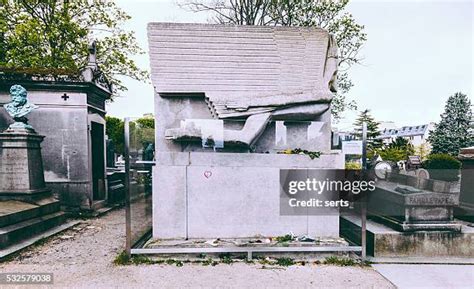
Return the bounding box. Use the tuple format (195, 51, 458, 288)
(181, 0, 367, 119)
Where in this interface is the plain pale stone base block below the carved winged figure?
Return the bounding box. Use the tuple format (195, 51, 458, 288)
(153, 152, 344, 238)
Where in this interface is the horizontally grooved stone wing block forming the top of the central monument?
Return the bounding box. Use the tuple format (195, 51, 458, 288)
(148, 23, 337, 95)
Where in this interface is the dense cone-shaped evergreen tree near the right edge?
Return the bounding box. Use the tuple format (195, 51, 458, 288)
(428, 92, 474, 156)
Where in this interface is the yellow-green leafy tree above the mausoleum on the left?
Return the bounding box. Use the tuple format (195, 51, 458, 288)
(0, 0, 148, 93)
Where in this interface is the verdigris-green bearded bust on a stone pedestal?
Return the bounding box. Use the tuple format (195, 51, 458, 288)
(3, 85, 38, 129)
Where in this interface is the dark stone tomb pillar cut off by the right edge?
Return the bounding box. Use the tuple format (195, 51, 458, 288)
(454, 147, 474, 222)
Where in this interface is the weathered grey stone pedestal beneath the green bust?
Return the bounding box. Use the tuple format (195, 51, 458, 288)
(0, 129, 50, 200)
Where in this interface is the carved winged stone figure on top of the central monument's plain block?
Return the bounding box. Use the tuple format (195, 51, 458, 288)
(149, 23, 337, 147)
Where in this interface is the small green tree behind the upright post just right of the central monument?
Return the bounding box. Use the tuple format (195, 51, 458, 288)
(354, 109, 383, 158)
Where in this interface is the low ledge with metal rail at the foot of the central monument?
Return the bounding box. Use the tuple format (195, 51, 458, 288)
(137, 236, 360, 263)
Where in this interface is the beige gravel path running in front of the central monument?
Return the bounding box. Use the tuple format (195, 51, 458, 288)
(0, 209, 395, 289)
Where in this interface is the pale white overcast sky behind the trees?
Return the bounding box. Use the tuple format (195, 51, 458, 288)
(108, 0, 474, 129)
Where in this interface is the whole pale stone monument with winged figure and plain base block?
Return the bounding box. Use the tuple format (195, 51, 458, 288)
(148, 23, 344, 238)
